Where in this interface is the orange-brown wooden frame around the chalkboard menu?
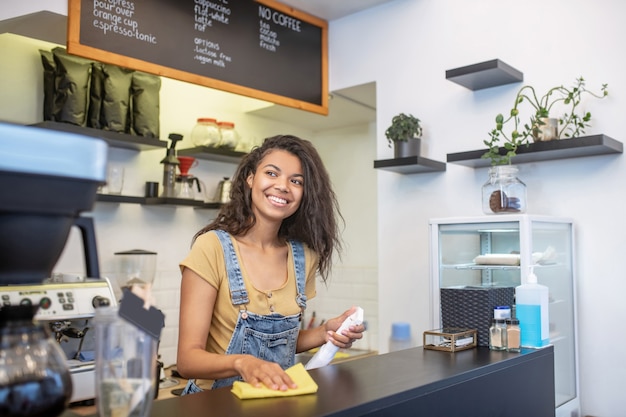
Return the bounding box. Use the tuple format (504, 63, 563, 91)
(67, 0, 328, 115)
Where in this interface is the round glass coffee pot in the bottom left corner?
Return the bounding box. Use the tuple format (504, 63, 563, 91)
(0, 305, 72, 417)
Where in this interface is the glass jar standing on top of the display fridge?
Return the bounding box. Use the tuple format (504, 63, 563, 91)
(482, 165, 526, 214)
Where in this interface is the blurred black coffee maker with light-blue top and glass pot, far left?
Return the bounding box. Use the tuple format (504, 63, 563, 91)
(0, 123, 107, 417)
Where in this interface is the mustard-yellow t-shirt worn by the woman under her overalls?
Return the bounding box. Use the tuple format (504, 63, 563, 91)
(180, 232, 318, 353)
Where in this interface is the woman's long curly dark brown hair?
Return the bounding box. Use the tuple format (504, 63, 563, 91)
(193, 135, 343, 282)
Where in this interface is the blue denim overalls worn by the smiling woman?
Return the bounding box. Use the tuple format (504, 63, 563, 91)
(181, 230, 306, 395)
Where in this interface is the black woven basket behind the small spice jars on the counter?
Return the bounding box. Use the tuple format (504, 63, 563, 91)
(441, 287, 515, 346)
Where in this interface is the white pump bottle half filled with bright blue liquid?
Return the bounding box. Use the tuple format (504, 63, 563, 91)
(515, 266, 550, 348)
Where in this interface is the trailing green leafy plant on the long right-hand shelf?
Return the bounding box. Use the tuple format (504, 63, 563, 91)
(482, 77, 609, 165)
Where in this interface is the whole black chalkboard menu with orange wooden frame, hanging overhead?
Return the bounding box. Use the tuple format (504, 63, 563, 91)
(67, 0, 328, 114)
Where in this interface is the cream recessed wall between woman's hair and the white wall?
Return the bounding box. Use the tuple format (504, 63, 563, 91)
(308, 124, 380, 350)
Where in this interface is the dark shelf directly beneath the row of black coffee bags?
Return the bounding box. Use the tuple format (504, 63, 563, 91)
(32, 121, 167, 151)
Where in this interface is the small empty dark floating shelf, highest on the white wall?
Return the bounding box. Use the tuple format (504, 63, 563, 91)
(446, 59, 524, 91)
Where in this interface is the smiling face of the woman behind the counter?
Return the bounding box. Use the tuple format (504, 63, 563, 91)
(247, 149, 304, 221)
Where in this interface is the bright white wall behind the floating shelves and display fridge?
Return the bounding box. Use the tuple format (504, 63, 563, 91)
(329, 0, 626, 417)
